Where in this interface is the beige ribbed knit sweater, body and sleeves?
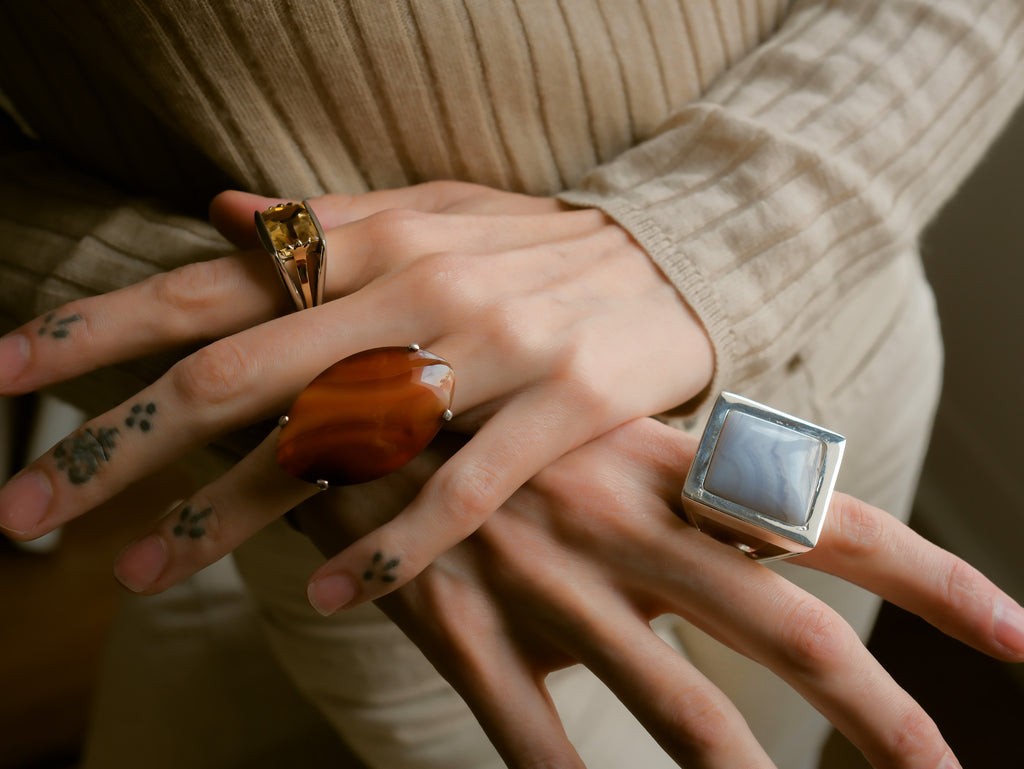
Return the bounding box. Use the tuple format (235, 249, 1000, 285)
(0, 0, 1024, 421)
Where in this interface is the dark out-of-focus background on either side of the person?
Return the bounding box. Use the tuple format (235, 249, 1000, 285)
(0, 105, 1024, 769)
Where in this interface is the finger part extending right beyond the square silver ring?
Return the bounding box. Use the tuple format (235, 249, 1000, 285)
(796, 493, 1024, 663)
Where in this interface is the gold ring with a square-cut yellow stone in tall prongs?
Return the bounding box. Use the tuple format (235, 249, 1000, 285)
(256, 201, 327, 309)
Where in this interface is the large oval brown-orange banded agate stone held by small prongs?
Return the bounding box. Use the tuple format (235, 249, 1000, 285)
(278, 346, 455, 485)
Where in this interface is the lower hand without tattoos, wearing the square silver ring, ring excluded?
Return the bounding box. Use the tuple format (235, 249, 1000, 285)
(292, 420, 1024, 769)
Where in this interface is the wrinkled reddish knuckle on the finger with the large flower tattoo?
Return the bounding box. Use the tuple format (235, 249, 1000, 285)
(171, 338, 255, 407)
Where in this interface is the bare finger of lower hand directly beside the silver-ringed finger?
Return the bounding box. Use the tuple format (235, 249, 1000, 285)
(645, 525, 951, 769)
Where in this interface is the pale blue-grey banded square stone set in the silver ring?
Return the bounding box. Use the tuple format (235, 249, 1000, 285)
(703, 411, 824, 526)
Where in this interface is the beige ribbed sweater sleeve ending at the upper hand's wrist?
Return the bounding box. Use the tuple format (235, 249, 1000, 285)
(561, 0, 1024, 405)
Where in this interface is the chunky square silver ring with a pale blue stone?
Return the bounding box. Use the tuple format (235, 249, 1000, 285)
(683, 392, 846, 561)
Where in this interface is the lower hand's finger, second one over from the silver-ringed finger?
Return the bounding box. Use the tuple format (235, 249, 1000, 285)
(563, 596, 774, 769)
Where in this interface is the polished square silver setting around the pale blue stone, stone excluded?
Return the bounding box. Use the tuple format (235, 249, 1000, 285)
(683, 392, 846, 560)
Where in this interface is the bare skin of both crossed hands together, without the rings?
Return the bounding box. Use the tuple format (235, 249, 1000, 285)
(0, 184, 1024, 767)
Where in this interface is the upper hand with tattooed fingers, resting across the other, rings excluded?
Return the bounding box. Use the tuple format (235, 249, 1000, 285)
(0, 182, 712, 607)
